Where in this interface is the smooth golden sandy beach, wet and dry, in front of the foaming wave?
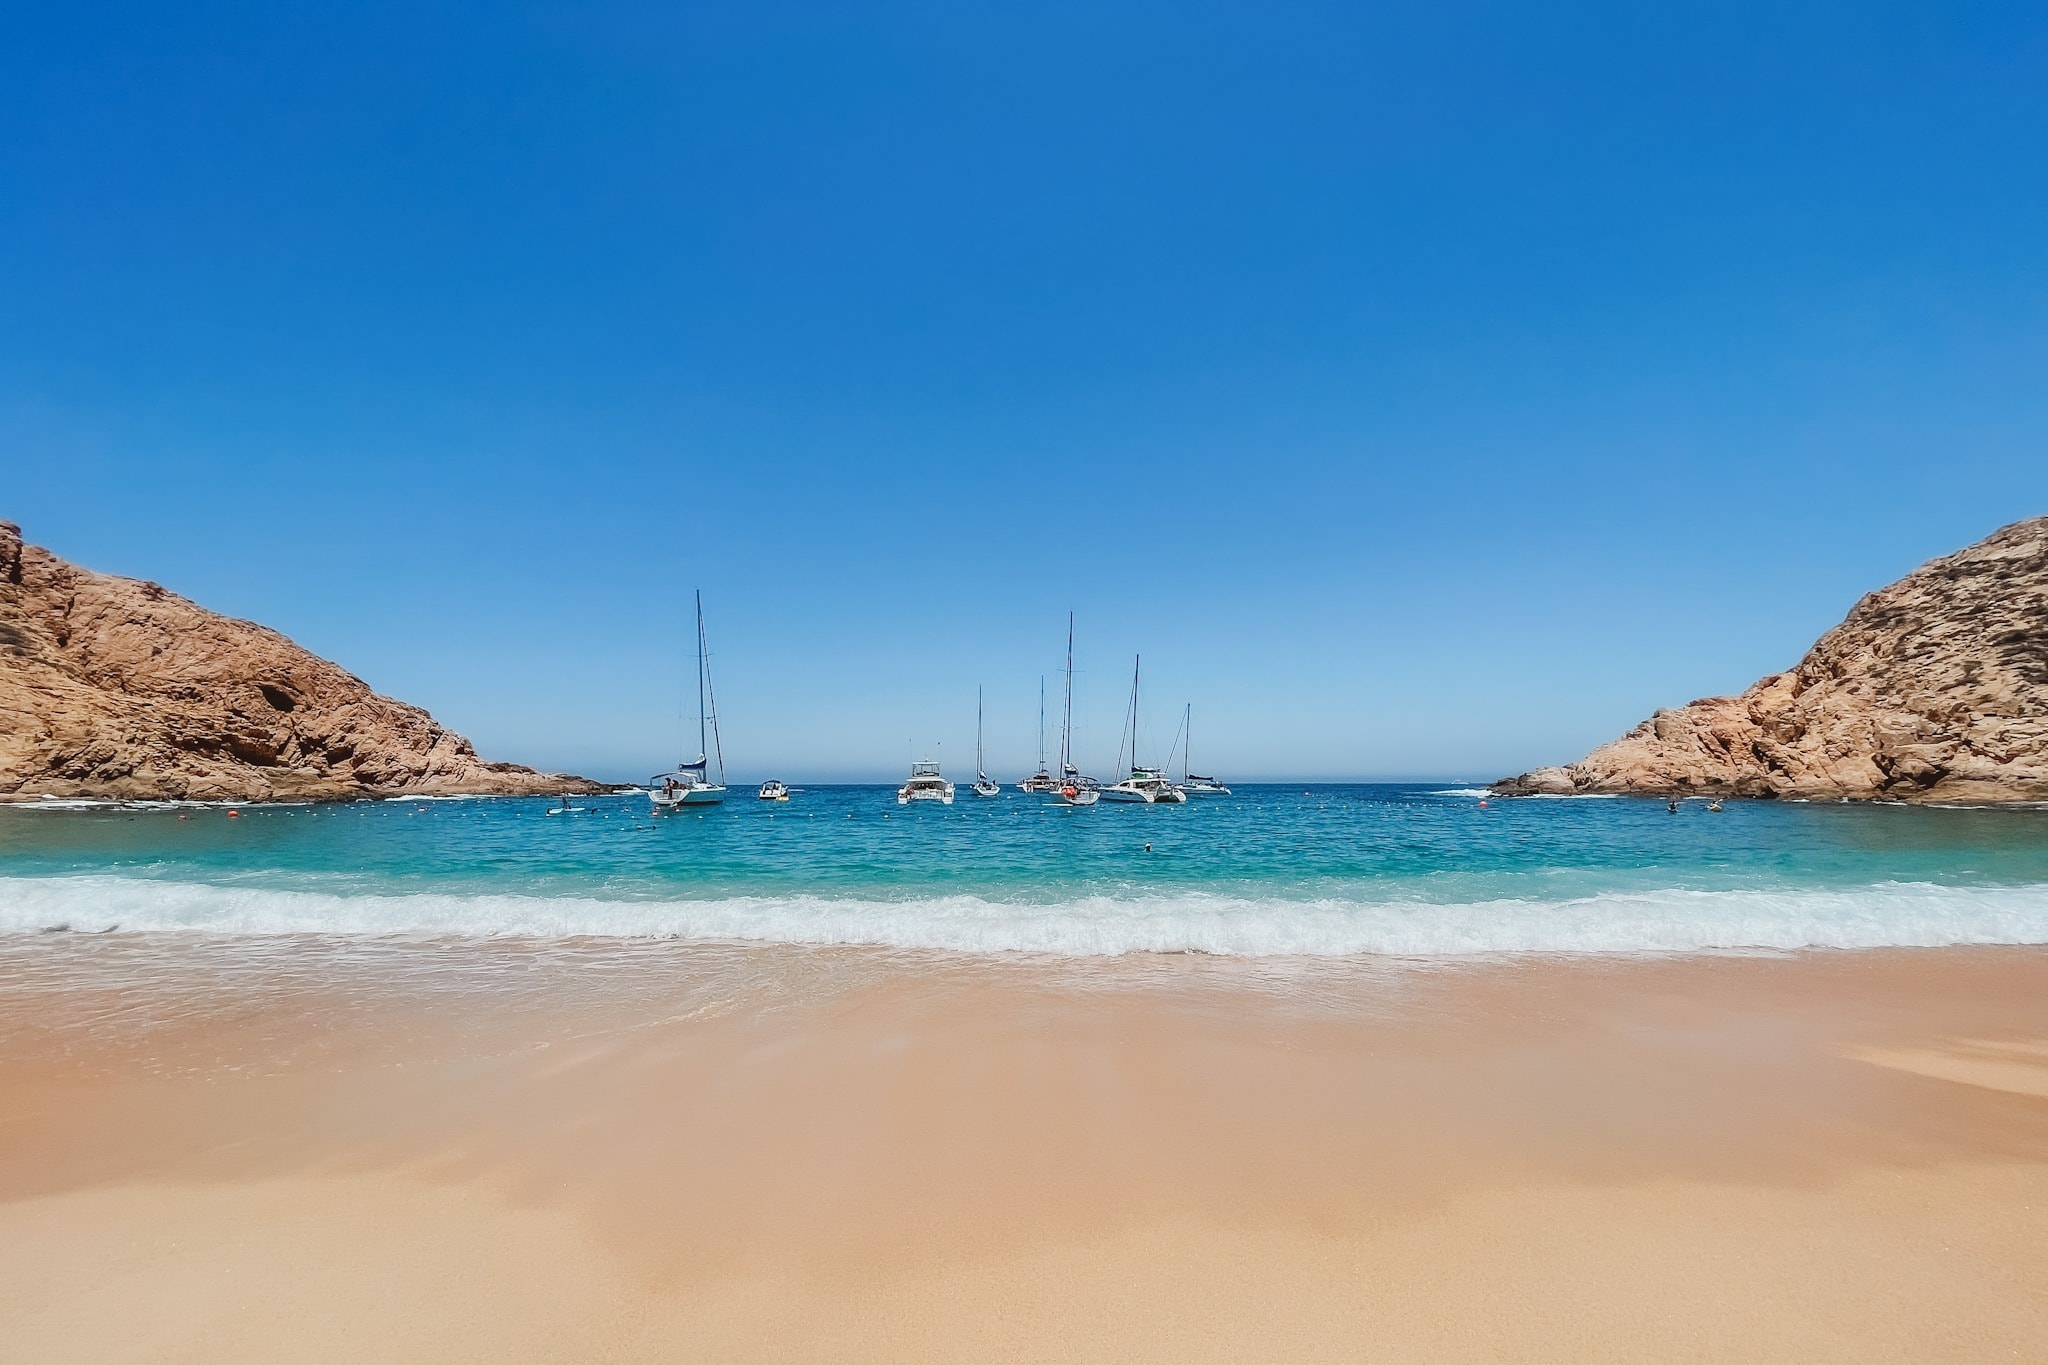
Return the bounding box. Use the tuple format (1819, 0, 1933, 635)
(0, 935, 2048, 1361)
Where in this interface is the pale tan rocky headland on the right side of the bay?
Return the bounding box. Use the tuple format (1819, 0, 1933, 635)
(1495, 518, 2048, 802)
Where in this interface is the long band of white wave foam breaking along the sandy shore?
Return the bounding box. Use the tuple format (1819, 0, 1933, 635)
(0, 874, 2048, 958)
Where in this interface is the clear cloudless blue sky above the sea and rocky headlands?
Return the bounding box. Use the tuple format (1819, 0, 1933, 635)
(0, 0, 2048, 780)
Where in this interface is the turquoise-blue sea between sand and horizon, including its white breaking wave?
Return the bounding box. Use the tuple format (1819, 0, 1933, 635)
(0, 786, 2048, 956)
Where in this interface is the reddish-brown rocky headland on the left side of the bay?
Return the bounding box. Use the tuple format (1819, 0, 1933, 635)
(0, 522, 602, 800)
